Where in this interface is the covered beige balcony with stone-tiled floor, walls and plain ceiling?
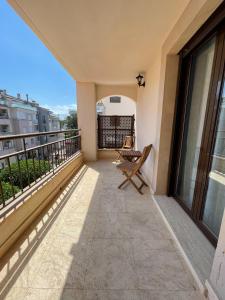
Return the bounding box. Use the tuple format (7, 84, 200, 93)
(0, 0, 225, 300)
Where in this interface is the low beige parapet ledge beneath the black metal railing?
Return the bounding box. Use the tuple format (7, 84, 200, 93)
(0, 153, 83, 257)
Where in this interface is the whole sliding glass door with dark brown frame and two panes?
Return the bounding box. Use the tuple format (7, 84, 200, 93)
(169, 4, 225, 245)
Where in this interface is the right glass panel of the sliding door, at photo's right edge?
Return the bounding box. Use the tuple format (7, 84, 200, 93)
(203, 80, 225, 237)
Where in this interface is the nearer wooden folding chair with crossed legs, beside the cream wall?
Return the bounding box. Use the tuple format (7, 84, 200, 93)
(117, 145, 152, 195)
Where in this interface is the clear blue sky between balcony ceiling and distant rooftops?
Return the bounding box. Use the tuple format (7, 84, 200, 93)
(0, 0, 76, 114)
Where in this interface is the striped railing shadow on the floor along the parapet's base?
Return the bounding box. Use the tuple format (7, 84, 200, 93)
(0, 166, 87, 299)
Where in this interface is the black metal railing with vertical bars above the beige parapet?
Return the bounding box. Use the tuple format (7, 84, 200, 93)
(0, 129, 81, 210)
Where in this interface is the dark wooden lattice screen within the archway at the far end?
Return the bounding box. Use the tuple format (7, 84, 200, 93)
(98, 115, 134, 149)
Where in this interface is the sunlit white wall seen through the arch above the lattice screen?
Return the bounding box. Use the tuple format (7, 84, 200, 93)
(98, 95, 136, 116)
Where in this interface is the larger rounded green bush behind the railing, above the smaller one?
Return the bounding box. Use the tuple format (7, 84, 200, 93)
(0, 159, 51, 188)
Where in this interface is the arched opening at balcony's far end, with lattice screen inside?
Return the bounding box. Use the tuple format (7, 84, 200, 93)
(96, 95, 136, 149)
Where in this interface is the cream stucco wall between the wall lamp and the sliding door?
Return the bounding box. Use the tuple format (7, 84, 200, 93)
(137, 0, 221, 194)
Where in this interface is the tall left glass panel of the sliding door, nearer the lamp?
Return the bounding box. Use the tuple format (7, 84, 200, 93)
(177, 38, 215, 210)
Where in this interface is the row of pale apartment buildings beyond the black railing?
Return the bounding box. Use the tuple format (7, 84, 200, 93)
(0, 90, 60, 155)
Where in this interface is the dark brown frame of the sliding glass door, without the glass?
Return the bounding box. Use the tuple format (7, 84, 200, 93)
(168, 2, 225, 245)
